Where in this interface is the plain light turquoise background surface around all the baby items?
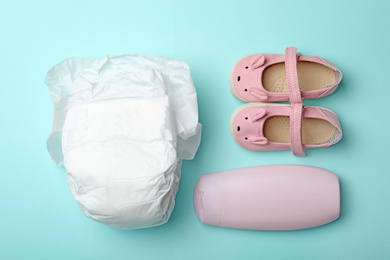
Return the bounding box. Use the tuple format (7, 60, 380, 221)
(0, 0, 390, 259)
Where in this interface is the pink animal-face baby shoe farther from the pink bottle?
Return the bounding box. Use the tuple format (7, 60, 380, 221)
(229, 47, 342, 103)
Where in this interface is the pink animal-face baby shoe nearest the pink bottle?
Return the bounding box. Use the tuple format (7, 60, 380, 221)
(230, 102, 342, 156)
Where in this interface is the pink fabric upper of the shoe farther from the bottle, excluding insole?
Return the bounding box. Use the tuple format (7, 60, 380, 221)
(230, 47, 342, 102)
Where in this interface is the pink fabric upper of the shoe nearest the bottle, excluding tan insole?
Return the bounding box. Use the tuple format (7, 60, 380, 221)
(231, 103, 342, 152)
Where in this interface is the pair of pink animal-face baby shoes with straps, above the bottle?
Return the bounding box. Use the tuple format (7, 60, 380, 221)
(229, 47, 342, 156)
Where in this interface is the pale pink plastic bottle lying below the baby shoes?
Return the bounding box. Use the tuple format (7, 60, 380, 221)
(194, 165, 340, 230)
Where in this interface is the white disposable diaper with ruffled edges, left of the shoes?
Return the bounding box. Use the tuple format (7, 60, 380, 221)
(46, 54, 201, 229)
